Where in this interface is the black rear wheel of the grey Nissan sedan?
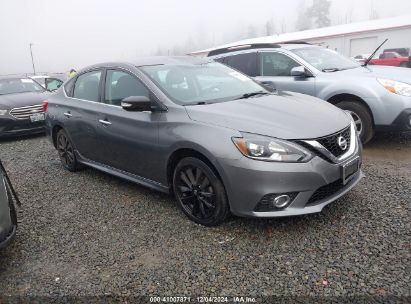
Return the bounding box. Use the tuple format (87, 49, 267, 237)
(56, 129, 82, 172)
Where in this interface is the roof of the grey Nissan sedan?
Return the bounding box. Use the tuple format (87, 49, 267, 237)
(79, 56, 211, 74)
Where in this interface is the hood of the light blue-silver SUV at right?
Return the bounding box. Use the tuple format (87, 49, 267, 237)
(327, 65, 411, 84)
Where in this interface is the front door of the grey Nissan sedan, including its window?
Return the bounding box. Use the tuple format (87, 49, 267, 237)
(98, 69, 162, 180)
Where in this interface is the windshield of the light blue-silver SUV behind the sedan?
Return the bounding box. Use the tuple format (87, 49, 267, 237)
(292, 47, 360, 72)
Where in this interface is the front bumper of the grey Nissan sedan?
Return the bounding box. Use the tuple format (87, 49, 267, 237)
(220, 147, 364, 218)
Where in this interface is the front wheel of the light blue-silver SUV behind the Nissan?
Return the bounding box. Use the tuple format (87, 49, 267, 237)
(336, 100, 374, 144)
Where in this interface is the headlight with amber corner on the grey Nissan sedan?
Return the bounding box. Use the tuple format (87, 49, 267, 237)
(233, 133, 312, 163)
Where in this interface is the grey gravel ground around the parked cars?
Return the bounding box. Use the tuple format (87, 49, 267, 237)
(0, 133, 411, 302)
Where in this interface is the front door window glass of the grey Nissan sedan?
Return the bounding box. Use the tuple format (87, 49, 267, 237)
(104, 70, 150, 106)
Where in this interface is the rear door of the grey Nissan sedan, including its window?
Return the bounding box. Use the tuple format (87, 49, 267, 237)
(64, 69, 102, 161)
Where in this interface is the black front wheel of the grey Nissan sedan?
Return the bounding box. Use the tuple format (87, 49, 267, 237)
(173, 157, 230, 226)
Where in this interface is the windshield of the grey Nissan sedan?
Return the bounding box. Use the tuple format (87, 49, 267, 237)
(141, 62, 267, 105)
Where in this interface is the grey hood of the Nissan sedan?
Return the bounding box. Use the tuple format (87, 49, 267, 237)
(186, 92, 350, 139)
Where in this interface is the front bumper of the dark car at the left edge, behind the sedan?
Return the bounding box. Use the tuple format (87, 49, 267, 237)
(0, 116, 45, 137)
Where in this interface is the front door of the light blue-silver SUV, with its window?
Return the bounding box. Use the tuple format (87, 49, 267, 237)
(256, 51, 315, 96)
